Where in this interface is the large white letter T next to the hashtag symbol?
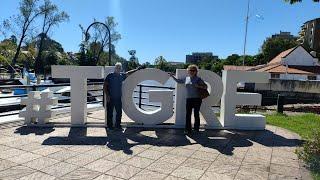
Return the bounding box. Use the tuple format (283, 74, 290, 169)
(51, 66, 104, 125)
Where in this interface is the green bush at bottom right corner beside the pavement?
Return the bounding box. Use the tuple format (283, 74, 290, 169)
(297, 130, 320, 177)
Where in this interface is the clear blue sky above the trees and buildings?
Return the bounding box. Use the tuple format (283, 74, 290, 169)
(0, 0, 320, 63)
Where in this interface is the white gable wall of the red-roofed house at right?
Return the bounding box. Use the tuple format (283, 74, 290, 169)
(282, 46, 318, 66)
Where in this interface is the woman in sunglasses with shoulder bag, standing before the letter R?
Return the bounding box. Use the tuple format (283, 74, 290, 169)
(170, 65, 207, 134)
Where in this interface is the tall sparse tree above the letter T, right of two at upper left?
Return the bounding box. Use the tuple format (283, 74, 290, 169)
(35, 0, 69, 74)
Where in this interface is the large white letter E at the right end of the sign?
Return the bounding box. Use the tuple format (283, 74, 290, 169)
(220, 71, 269, 130)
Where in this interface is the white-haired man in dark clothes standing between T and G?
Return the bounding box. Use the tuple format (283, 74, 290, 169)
(103, 62, 142, 130)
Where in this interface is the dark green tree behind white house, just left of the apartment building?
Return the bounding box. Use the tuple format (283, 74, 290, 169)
(260, 38, 299, 64)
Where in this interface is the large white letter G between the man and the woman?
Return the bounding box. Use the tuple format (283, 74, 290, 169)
(122, 68, 173, 125)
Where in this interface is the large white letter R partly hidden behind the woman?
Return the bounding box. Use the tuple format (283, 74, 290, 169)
(175, 69, 223, 128)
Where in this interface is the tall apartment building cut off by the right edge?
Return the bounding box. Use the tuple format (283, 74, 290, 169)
(298, 18, 320, 53)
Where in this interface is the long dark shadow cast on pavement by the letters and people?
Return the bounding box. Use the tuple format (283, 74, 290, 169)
(20, 126, 302, 155)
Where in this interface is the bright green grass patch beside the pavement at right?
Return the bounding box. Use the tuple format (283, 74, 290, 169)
(266, 113, 320, 139)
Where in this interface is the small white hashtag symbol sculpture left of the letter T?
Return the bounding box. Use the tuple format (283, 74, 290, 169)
(19, 91, 58, 124)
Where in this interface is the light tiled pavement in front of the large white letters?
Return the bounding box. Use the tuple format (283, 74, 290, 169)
(0, 111, 310, 180)
